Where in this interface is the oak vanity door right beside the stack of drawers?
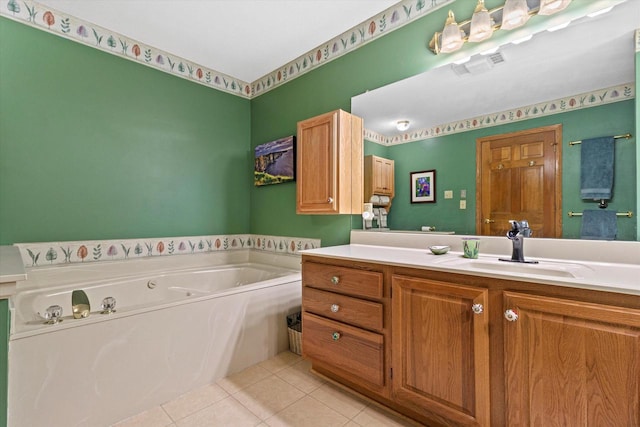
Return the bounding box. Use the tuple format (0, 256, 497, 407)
(391, 275, 490, 426)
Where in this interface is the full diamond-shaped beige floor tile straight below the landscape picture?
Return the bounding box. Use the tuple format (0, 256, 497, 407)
(233, 375, 305, 420)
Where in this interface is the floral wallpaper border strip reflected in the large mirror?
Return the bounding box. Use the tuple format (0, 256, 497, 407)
(364, 83, 635, 145)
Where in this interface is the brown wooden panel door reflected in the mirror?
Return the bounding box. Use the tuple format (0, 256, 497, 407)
(476, 125, 562, 237)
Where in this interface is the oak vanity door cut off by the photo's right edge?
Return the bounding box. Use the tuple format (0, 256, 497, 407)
(504, 292, 640, 427)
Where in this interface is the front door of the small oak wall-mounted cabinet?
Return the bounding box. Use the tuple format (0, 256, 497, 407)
(296, 112, 338, 213)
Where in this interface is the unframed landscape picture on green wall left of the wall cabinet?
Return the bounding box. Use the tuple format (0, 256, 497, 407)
(253, 136, 296, 186)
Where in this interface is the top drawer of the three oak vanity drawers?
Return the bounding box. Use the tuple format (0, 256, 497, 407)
(302, 262, 383, 299)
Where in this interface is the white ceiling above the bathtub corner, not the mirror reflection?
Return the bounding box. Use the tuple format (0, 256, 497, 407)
(38, 0, 399, 82)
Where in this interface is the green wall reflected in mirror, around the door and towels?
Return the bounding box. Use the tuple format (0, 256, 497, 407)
(388, 100, 637, 240)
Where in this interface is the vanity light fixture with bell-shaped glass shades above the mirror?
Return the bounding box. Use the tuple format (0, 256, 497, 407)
(429, 0, 571, 55)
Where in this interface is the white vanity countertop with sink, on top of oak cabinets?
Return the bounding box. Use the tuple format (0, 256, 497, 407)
(302, 244, 640, 295)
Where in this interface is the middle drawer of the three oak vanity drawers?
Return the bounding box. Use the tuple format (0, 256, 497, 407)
(302, 287, 383, 331)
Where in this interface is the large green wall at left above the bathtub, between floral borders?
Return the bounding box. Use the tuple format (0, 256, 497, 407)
(0, 18, 252, 244)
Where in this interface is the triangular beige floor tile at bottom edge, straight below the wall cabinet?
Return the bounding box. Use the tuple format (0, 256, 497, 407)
(266, 396, 349, 427)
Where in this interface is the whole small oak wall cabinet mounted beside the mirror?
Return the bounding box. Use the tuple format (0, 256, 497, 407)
(296, 110, 364, 214)
